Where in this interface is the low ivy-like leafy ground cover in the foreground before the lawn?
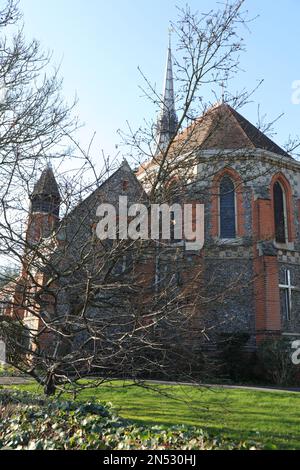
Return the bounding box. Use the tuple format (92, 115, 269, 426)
(0, 390, 260, 450)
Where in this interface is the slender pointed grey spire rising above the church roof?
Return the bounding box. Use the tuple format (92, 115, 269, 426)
(156, 34, 178, 153)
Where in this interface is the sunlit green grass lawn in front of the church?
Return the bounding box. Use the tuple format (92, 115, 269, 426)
(12, 382, 300, 449)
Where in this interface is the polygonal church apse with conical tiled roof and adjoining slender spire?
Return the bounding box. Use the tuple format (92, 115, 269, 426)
(137, 41, 300, 347)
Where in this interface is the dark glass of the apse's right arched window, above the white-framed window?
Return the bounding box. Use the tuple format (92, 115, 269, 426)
(273, 181, 287, 243)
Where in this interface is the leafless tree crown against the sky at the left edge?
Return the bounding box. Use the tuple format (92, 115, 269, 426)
(0, 0, 77, 255)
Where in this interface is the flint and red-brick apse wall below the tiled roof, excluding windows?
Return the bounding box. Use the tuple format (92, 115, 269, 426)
(195, 155, 300, 344)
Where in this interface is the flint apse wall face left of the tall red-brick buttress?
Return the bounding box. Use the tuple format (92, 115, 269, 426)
(190, 156, 255, 345)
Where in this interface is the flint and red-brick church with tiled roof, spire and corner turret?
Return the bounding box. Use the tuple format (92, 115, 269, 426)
(0, 42, 300, 362)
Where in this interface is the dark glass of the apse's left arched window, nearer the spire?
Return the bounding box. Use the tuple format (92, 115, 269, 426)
(220, 175, 236, 238)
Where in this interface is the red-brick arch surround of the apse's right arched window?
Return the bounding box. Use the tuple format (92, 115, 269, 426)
(270, 172, 296, 242)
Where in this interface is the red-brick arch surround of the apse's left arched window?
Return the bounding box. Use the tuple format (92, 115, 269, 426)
(211, 167, 245, 237)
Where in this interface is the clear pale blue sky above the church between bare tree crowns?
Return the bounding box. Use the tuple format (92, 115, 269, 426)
(20, 0, 300, 162)
